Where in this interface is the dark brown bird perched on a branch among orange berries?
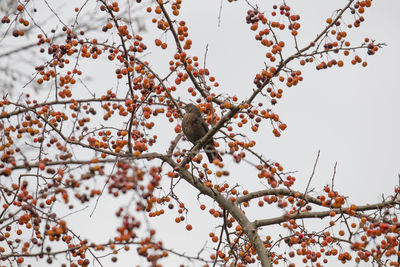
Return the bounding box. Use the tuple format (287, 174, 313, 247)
(182, 103, 222, 163)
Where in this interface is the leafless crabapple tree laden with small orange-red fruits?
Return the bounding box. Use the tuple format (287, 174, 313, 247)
(0, 0, 400, 267)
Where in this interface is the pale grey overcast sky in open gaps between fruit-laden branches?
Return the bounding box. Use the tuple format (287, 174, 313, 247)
(0, 0, 400, 266)
